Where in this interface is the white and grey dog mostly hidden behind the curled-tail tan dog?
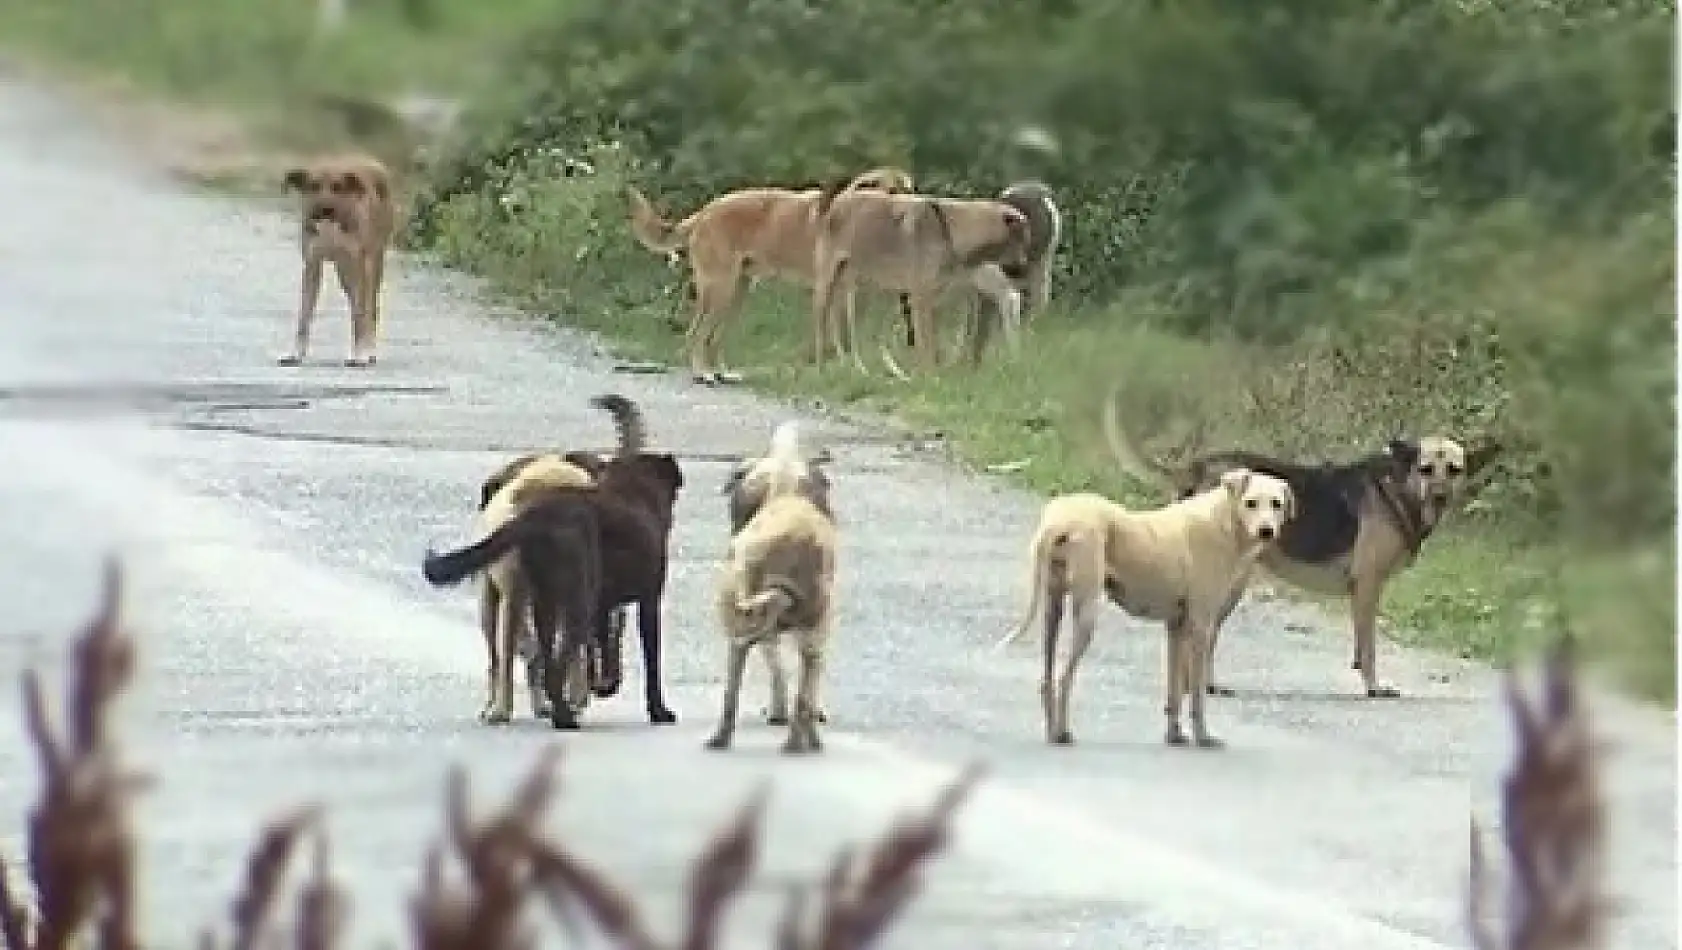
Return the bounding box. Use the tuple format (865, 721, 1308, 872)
(722, 420, 834, 725)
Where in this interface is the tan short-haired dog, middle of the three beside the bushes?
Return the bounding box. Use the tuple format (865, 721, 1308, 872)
(812, 190, 1031, 370)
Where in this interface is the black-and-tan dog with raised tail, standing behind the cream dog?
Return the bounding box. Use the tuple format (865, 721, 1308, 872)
(1103, 392, 1500, 698)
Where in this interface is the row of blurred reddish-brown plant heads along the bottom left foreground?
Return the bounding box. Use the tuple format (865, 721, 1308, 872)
(0, 565, 981, 950)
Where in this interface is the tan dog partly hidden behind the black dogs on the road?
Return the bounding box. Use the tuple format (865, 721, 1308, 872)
(474, 454, 595, 723)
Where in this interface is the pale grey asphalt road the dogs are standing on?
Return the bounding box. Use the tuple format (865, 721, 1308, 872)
(0, 77, 1677, 950)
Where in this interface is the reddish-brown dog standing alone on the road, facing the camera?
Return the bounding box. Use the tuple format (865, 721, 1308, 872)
(279, 155, 397, 367)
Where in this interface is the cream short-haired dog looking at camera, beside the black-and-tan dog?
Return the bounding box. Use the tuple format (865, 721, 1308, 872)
(997, 469, 1295, 748)
